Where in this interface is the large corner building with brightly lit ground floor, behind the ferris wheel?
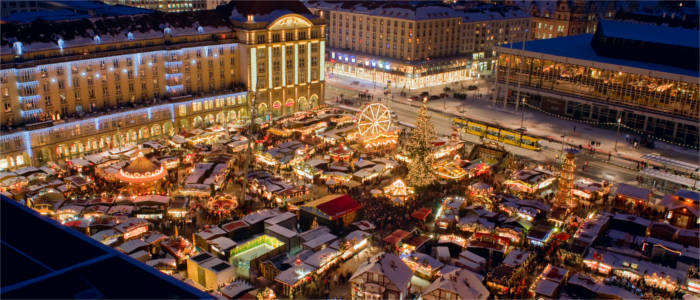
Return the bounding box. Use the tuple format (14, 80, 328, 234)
(306, 1, 529, 89)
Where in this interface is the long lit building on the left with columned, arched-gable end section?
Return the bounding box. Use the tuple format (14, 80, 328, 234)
(0, 1, 325, 170)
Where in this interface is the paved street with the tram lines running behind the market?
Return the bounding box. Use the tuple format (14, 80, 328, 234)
(327, 75, 700, 167)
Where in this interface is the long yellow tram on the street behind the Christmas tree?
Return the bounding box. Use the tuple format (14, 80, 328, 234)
(452, 118, 542, 151)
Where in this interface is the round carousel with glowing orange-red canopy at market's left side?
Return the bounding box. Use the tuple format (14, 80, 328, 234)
(116, 152, 168, 192)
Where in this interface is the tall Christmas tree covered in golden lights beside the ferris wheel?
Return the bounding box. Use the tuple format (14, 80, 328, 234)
(405, 103, 437, 187)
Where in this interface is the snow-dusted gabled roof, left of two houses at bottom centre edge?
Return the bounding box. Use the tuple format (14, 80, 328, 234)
(350, 253, 413, 295)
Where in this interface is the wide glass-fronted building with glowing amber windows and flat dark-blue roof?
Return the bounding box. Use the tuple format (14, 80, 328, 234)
(496, 21, 700, 148)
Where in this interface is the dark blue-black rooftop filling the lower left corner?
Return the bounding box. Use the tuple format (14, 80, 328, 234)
(0, 196, 212, 299)
